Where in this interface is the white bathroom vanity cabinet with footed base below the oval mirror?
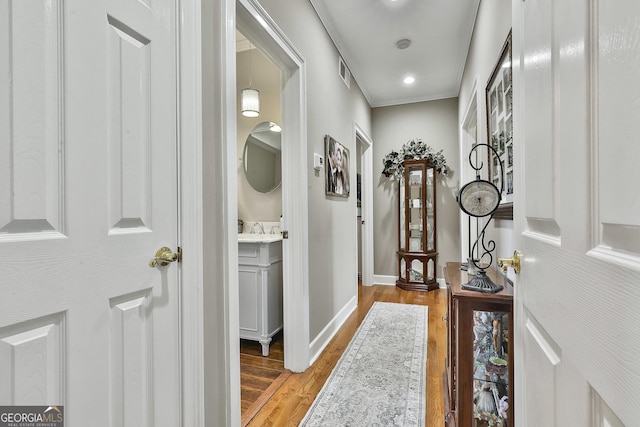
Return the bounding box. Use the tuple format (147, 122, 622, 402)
(238, 239, 282, 356)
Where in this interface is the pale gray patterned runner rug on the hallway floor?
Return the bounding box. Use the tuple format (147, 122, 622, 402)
(300, 302, 429, 427)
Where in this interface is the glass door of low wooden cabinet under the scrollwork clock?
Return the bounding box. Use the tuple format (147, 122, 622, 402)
(472, 310, 509, 427)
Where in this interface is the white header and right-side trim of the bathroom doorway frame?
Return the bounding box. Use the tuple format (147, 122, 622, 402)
(239, 0, 309, 372)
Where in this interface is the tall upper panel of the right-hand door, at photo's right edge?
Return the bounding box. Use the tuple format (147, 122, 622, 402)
(593, 0, 640, 270)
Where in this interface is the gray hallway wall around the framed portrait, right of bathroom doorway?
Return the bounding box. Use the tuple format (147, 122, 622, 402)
(260, 0, 371, 340)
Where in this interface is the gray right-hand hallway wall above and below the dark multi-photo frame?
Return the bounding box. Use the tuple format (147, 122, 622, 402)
(458, 0, 518, 259)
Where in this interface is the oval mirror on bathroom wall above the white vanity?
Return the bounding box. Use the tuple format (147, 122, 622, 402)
(242, 122, 282, 193)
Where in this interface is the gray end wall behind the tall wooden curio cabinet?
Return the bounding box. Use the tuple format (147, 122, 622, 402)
(372, 98, 460, 277)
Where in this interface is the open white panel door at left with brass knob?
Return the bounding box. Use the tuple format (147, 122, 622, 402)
(0, 0, 180, 427)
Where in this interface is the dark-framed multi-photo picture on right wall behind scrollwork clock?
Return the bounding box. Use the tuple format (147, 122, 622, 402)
(486, 31, 513, 219)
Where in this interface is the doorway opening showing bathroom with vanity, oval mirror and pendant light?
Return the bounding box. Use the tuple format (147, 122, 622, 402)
(236, 30, 285, 425)
